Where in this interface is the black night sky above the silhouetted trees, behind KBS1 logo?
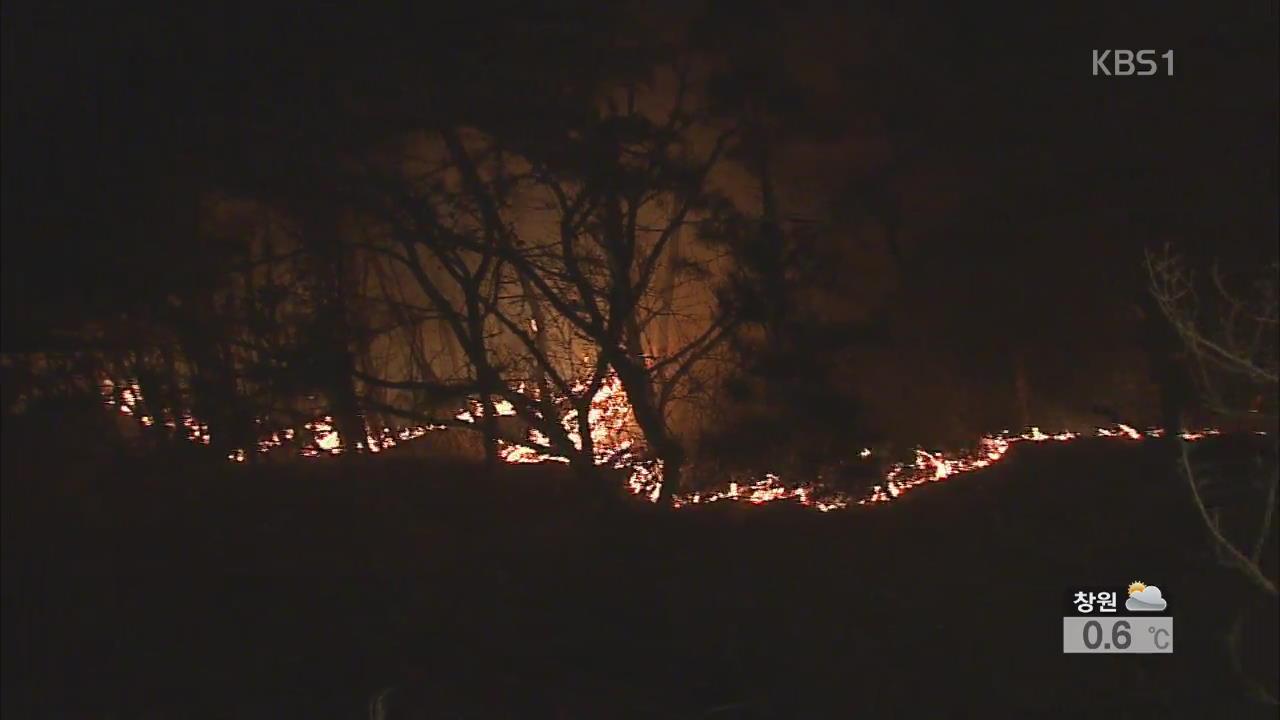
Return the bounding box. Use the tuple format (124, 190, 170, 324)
(4, 0, 1277, 358)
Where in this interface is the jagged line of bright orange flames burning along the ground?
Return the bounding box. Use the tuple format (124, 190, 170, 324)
(102, 373, 1239, 512)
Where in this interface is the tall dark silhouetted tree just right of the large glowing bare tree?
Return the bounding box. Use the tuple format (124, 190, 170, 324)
(701, 22, 878, 482)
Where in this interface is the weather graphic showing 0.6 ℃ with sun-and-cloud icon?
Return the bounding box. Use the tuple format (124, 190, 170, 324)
(1062, 580, 1174, 655)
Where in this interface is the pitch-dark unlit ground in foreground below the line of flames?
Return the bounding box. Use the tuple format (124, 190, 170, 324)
(4, 427, 1276, 720)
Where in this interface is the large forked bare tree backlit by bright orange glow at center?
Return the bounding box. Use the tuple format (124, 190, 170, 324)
(345, 68, 733, 498)
